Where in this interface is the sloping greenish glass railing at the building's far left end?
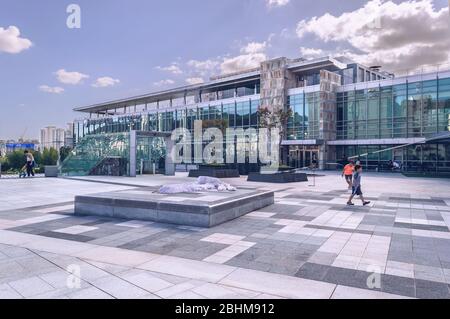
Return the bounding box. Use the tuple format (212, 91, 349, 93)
(60, 133, 130, 176)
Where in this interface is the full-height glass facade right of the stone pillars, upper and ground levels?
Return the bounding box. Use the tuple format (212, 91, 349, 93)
(336, 78, 450, 172)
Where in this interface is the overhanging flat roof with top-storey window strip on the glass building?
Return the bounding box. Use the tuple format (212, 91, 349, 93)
(74, 57, 388, 115)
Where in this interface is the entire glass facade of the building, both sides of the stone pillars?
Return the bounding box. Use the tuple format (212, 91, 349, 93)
(70, 66, 450, 175)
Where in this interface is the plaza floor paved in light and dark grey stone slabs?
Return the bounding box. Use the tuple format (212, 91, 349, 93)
(0, 172, 450, 299)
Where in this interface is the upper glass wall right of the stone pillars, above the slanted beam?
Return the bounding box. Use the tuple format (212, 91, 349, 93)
(337, 78, 450, 140)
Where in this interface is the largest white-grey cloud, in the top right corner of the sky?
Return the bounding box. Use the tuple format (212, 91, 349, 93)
(297, 0, 450, 71)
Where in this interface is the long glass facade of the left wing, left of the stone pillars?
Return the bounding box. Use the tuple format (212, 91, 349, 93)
(74, 99, 260, 174)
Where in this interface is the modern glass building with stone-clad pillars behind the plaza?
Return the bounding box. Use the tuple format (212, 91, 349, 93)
(63, 57, 450, 175)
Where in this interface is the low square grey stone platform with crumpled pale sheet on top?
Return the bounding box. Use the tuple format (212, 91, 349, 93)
(75, 187, 274, 227)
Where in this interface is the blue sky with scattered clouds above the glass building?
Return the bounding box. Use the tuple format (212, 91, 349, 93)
(0, 0, 450, 139)
